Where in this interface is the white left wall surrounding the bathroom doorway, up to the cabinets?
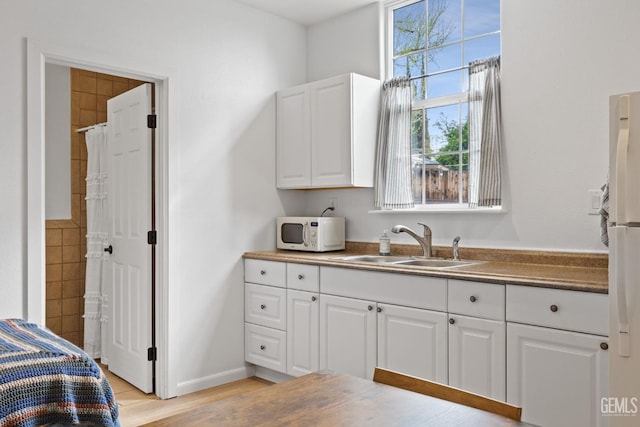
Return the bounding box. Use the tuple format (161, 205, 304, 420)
(0, 0, 306, 392)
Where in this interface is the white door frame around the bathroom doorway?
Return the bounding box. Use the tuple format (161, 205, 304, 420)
(23, 38, 179, 399)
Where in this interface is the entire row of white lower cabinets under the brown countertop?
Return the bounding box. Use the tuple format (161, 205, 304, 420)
(245, 260, 608, 427)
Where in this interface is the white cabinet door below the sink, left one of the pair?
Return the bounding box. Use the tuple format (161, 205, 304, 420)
(320, 295, 376, 379)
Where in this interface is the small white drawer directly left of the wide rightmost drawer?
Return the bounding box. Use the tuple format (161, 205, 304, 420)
(448, 279, 504, 320)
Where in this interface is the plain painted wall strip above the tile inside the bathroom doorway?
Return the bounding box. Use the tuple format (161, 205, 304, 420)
(44, 64, 71, 219)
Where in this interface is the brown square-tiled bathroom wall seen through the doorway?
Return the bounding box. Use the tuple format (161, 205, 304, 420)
(46, 68, 143, 347)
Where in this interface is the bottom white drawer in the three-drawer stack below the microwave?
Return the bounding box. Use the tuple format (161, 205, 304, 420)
(244, 323, 287, 372)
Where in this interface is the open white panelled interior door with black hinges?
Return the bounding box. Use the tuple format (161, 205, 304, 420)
(106, 84, 153, 393)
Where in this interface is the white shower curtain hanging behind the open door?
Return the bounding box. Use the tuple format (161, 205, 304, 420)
(84, 126, 108, 363)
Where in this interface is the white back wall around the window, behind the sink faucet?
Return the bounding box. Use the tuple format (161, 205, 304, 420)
(307, 0, 640, 252)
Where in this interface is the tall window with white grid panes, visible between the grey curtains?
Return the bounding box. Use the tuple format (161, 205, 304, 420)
(386, 0, 501, 205)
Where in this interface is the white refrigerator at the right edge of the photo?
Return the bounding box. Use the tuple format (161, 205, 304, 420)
(601, 92, 640, 427)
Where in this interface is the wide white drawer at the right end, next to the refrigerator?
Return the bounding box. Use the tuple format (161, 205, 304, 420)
(507, 285, 609, 336)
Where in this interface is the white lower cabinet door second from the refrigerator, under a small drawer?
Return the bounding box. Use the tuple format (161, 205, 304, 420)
(449, 314, 507, 401)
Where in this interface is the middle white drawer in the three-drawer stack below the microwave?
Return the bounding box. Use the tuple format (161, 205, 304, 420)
(244, 283, 287, 331)
